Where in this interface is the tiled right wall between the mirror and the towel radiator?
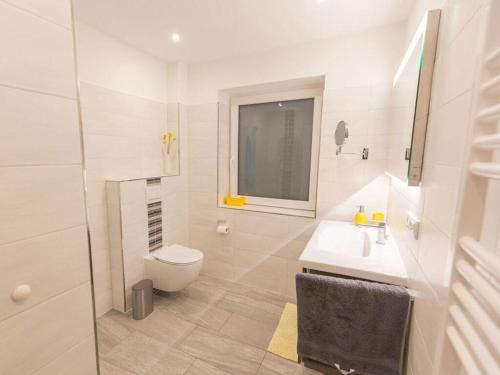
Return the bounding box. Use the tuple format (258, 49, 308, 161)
(388, 0, 486, 375)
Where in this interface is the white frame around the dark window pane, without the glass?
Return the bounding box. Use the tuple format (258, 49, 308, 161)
(229, 89, 323, 211)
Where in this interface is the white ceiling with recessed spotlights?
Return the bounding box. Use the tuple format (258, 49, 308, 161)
(73, 0, 414, 63)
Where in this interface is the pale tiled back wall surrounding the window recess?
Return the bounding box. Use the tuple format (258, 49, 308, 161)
(188, 24, 406, 298)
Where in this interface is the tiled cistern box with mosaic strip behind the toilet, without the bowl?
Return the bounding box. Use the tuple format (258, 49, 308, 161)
(106, 177, 165, 312)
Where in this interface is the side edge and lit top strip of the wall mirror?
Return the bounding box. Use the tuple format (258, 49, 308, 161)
(393, 9, 441, 186)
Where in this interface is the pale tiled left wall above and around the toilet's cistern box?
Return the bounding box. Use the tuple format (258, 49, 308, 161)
(76, 23, 187, 316)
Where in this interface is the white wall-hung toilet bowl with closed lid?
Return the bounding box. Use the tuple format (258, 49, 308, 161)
(144, 244, 203, 292)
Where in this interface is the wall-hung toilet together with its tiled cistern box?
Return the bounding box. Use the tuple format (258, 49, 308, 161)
(106, 177, 203, 312)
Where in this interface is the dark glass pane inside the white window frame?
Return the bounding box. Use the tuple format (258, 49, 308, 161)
(238, 98, 314, 201)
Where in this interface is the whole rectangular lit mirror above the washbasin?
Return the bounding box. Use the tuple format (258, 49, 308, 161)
(387, 10, 441, 186)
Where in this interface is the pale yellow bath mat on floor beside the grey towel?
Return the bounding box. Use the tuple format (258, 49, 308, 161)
(267, 303, 298, 362)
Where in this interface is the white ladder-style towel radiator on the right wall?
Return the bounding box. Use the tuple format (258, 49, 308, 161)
(443, 1, 500, 375)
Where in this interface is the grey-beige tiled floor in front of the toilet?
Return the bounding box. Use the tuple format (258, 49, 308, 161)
(97, 276, 348, 375)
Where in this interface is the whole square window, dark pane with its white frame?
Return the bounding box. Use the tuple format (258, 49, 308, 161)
(230, 90, 322, 211)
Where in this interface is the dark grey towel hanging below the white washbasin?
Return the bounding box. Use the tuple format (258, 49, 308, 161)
(296, 273, 410, 375)
